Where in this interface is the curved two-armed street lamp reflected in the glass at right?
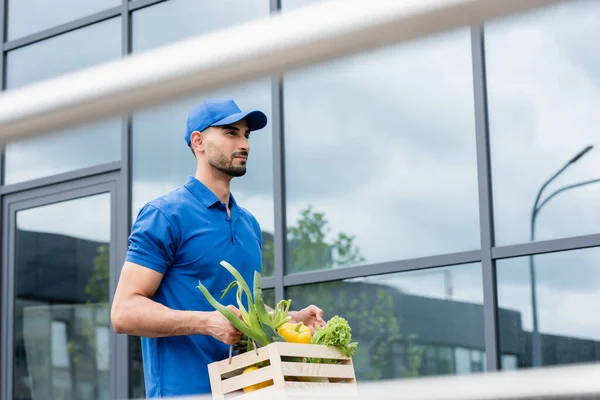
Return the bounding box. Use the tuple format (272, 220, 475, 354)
(529, 145, 600, 367)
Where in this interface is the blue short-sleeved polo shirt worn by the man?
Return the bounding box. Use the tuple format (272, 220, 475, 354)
(126, 177, 262, 397)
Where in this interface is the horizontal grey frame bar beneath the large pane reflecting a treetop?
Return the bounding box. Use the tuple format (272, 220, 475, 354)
(283, 250, 481, 287)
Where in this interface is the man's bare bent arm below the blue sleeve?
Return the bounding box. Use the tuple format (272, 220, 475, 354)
(111, 262, 241, 344)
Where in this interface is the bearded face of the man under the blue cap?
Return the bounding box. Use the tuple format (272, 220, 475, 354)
(205, 120, 250, 177)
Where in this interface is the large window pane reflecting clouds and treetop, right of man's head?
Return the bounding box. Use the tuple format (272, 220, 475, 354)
(283, 30, 480, 272)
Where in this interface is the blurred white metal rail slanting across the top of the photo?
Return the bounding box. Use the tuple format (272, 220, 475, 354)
(0, 0, 566, 145)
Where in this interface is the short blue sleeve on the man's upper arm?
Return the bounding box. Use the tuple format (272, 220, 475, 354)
(125, 204, 177, 274)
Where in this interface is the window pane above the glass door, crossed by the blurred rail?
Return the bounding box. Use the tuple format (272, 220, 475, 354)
(5, 18, 121, 184)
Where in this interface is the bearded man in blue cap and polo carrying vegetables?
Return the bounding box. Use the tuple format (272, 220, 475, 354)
(111, 100, 324, 397)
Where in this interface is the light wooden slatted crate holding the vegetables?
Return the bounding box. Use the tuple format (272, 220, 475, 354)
(208, 342, 357, 400)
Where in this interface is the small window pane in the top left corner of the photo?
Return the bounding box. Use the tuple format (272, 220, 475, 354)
(7, 0, 121, 40)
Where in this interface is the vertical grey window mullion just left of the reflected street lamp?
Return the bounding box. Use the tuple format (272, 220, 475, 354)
(471, 26, 500, 371)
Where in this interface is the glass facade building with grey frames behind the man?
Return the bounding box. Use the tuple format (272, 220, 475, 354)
(0, 0, 600, 400)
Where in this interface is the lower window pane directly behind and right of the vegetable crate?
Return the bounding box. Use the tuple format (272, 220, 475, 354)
(286, 263, 484, 381)
